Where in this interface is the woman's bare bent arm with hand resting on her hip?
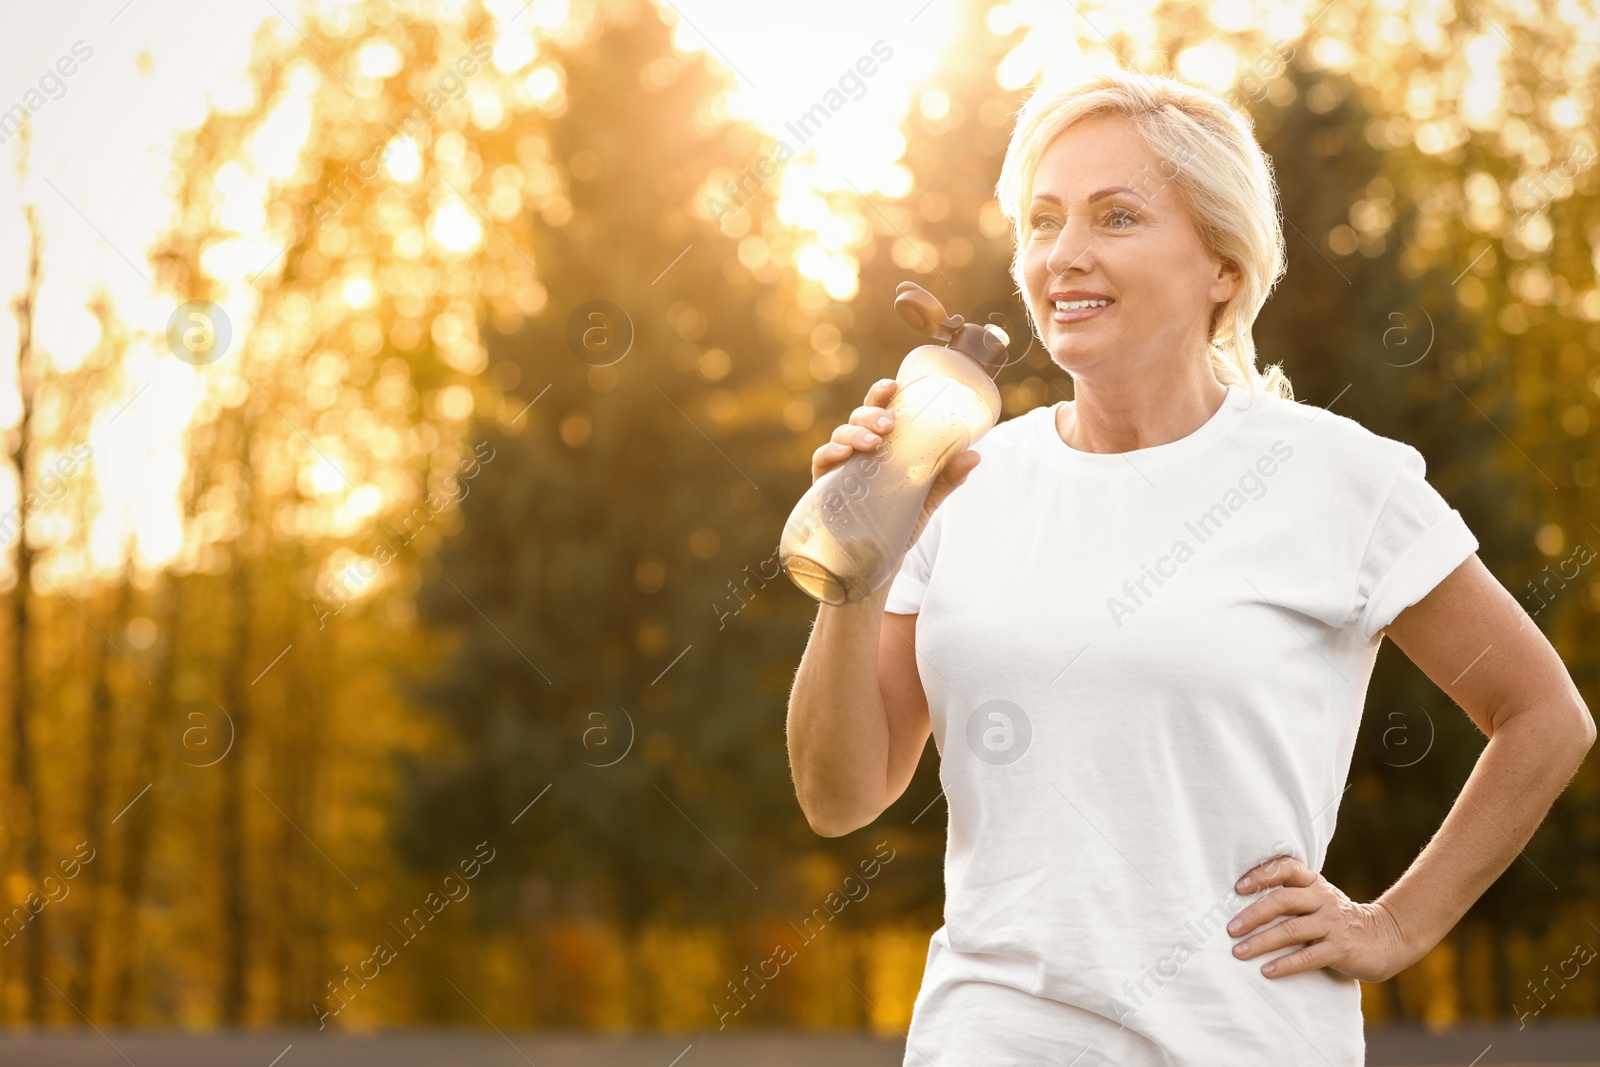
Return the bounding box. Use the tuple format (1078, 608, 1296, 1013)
(1229, 555, 1595, 982)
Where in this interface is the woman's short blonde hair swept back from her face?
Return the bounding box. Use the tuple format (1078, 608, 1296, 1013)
(995, 70, 1294, 400)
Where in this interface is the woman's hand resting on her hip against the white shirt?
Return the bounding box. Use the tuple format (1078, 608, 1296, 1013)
(1227, 856, 1422, 982)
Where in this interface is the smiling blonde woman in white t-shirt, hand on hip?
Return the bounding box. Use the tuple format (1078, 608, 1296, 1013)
(789, 74, 1595, 1067)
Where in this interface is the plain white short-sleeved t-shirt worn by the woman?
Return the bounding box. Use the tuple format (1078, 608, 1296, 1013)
(886, 386, 1478, 1067)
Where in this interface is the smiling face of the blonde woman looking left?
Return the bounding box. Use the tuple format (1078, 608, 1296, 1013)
(1022, 115, 1238, 381)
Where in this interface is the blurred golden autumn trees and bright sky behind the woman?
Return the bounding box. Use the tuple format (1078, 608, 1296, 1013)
(0, 0, 1600, 1067)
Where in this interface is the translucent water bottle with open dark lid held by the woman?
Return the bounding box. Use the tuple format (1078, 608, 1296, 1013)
(778, 282, 1008, 605)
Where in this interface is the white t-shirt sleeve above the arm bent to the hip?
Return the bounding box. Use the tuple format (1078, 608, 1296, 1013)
(1354, 443, 1478, 641)
